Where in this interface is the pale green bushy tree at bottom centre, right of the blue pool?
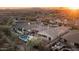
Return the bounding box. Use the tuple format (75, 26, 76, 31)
(27, 37, 45, 50)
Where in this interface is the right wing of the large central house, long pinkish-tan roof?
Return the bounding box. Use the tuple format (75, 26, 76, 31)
(38, 26, 70, 40)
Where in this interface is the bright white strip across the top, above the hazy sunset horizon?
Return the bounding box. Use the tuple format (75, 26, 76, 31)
(0, 0, 79, 7)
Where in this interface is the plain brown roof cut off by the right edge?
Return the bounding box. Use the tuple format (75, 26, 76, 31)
(62, 30, 79, 45)
